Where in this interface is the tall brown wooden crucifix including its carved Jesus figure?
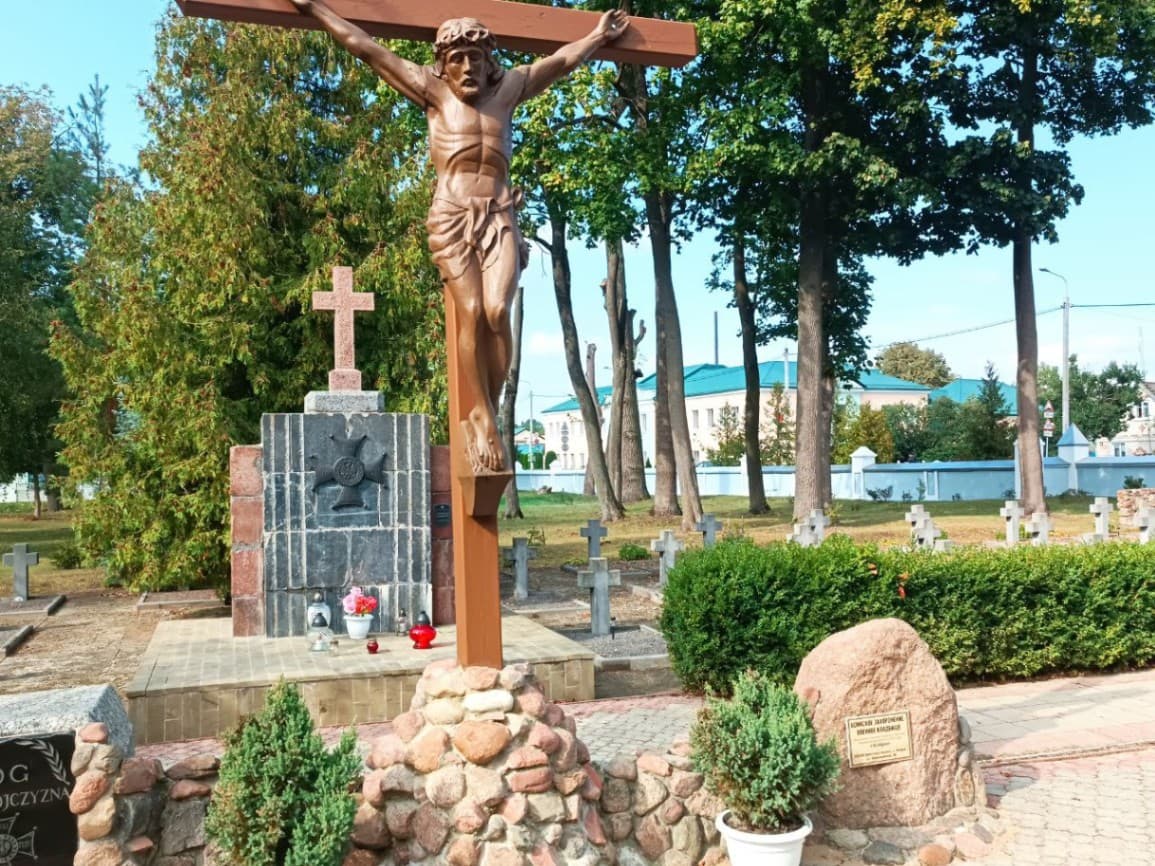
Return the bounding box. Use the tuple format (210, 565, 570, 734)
(178, 0, 698, 667)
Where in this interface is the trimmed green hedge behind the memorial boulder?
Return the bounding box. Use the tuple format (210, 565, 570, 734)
(661, 536, 1155, 694)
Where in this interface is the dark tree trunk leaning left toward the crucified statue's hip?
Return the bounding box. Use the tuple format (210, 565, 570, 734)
(546, 201, 625, 514)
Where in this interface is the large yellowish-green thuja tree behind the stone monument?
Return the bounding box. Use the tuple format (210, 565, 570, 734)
(55, 13, 445, 588)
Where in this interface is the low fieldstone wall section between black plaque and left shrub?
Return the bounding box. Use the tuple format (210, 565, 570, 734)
(68, 723, 221, 866)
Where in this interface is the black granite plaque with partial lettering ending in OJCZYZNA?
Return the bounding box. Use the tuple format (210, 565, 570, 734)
(0, 733, 76, 866)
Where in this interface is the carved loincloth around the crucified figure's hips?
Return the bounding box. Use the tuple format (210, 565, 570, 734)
(425, 189, 529, 281)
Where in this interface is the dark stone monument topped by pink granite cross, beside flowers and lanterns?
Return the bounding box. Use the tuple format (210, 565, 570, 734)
(231, 268, 433, 637)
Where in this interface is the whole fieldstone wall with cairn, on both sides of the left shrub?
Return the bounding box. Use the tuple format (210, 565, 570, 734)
(72, 659, 728, 866)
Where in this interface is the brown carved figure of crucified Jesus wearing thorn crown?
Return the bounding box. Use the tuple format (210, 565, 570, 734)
(292, 0, 629, 475)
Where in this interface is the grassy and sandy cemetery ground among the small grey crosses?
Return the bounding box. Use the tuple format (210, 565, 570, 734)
(0, 493, 1118, 696)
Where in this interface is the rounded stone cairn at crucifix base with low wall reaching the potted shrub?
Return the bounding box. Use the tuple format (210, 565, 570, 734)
(345, 659, 717, 866)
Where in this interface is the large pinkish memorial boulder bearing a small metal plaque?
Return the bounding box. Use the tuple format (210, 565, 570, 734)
(795, 619, 959, 828)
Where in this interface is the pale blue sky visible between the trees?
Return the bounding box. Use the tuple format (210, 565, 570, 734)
(0, 0, 1155, 417)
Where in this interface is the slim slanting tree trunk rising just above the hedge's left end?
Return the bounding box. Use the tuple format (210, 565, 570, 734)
(643, 189, 702, 530)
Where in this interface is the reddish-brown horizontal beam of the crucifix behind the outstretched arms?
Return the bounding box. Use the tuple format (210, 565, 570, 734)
(170, 0, 698, 66)
